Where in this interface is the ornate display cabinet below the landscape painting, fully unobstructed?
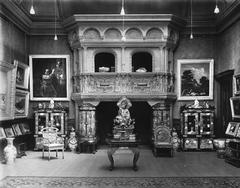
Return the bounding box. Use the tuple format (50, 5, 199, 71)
(181, 103, 214, 150)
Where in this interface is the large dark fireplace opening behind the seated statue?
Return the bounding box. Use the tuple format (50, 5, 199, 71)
(96, 101, 152, 145)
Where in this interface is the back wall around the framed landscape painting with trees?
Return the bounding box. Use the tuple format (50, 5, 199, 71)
(173, 35, 216, 119)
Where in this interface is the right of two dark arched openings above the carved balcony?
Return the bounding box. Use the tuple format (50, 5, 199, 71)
(132, 52, 152, 72)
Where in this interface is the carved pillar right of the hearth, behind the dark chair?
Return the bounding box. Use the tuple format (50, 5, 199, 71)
(152, 102, 172, 130)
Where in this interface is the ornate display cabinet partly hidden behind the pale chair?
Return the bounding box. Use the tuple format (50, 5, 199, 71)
(34, 109, 67, 150)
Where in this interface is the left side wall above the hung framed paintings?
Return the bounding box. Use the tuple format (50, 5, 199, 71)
(0, 18, 28, 63)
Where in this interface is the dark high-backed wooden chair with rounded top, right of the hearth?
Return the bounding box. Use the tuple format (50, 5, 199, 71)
(153, 125, 173, 157)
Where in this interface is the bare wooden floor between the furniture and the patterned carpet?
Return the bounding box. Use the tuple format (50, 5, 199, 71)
(0, 148, 240, 179)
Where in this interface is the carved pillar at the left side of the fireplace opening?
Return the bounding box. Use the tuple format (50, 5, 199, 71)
(78, 103, 96, 137)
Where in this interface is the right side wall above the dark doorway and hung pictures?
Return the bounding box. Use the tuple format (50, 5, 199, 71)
(216, 20, 240, 74)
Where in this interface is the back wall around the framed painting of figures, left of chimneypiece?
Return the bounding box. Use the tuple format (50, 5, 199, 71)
(29, 35, 74, 118)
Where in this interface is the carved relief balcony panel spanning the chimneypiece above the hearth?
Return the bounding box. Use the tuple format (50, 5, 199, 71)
(72, 72, 176, 101)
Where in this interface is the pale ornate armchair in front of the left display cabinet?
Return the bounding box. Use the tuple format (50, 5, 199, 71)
(41, 127, 64, 160)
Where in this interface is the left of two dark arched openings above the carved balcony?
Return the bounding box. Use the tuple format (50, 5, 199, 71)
(95, 52, 115, 72)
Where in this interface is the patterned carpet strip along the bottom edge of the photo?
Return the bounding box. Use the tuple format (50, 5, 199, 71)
(0, 176, 240, 188)
